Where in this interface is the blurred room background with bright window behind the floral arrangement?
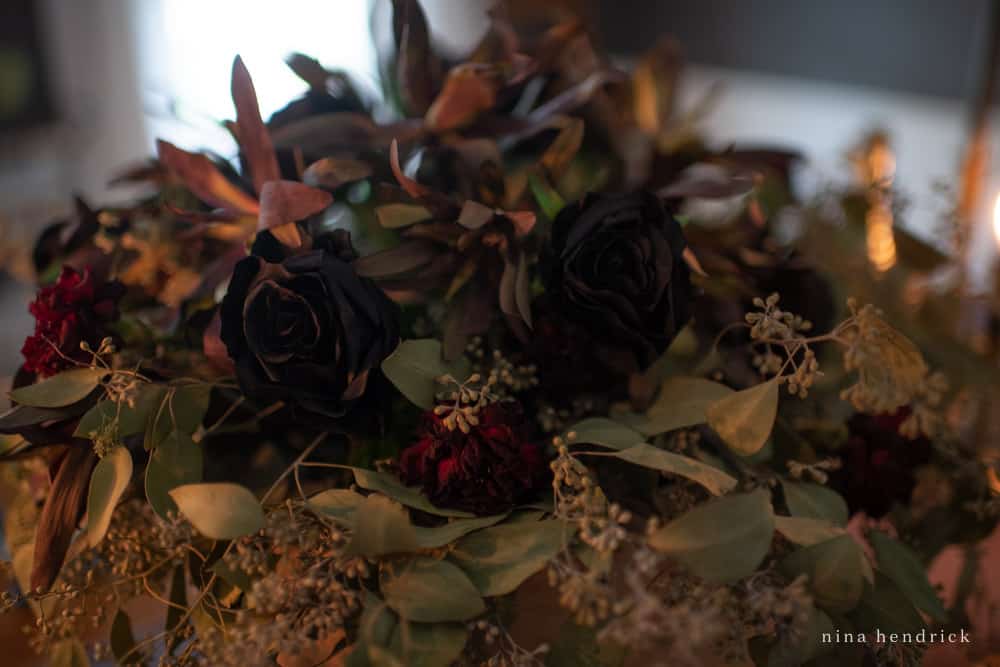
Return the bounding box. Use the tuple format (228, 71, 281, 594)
(0, 0, 1000, 368)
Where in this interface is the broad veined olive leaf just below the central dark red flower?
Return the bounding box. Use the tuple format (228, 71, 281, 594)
(449, 519, 570, 597)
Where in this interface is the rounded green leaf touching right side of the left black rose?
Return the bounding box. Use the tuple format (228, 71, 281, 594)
(382, 338, 469, 410)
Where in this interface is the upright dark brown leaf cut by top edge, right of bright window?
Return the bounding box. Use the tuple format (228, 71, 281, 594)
(392, 0, 441, 115)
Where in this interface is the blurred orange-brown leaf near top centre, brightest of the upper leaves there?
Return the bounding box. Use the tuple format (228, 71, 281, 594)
(424, 63, 502, 132)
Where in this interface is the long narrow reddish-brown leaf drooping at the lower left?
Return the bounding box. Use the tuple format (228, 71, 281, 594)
(31, 442, 97, 590)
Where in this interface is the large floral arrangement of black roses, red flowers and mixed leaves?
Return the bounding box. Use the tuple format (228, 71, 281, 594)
(0, 0, 990, 667)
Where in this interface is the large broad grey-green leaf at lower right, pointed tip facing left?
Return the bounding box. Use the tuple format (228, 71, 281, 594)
(649, 490, 774, 583)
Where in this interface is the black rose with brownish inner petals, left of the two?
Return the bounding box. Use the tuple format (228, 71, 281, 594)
(221, 247, 399, 418)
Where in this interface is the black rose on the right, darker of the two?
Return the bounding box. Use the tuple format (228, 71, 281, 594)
(545, 192, 691, 373)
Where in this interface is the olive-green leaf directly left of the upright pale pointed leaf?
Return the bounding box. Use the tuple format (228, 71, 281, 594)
(619, 377, 734, 436)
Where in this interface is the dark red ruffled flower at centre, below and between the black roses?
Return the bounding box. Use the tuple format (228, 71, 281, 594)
(400, 403, 546, 515)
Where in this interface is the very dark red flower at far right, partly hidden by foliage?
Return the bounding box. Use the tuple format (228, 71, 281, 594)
(830, 408, 931, 518)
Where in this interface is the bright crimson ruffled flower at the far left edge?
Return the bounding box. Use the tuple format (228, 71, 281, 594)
(21, 266, 125, 377)
